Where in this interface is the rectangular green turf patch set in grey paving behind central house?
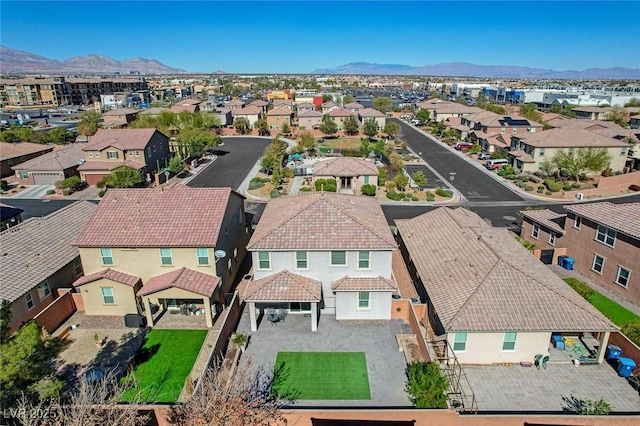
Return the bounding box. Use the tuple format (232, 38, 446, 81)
(273, 352, 371, 400)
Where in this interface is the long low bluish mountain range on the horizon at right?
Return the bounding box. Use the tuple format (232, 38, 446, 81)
(312, 62, 640, 80)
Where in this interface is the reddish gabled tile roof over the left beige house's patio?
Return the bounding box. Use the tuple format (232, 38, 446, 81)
(138, 267, 220, 297)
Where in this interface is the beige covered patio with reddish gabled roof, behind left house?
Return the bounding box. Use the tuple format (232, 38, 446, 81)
(138, 268, 224, 328)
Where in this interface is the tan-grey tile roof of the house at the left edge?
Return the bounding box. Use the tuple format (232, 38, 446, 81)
(0, 201, 97, 302)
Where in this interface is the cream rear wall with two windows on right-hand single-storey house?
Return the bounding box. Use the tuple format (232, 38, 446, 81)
(447, 332, 551, 364)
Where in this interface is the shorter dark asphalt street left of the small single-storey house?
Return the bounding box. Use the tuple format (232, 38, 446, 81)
(187, 137, 271, 189)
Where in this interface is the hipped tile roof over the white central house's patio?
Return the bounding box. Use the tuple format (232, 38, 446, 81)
(238, 270, 322, 302)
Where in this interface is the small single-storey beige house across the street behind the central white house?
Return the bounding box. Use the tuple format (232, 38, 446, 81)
(313, 157, 379, 194)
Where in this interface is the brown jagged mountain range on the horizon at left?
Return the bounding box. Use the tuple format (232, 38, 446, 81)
(0, 45, 186, 75)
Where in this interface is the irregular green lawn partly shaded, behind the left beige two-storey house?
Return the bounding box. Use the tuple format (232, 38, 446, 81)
(129, 329, 207, 402)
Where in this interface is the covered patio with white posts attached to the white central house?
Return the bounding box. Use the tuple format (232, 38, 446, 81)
(238, 271, 322, 331)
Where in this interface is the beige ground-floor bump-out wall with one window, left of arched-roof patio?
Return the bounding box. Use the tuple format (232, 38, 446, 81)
(78, 279, 138, 316)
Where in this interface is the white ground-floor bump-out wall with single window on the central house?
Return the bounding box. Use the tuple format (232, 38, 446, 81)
(335, 291, 392, 320)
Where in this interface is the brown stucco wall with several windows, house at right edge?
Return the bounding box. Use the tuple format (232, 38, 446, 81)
(563, 213, 640, 303)
